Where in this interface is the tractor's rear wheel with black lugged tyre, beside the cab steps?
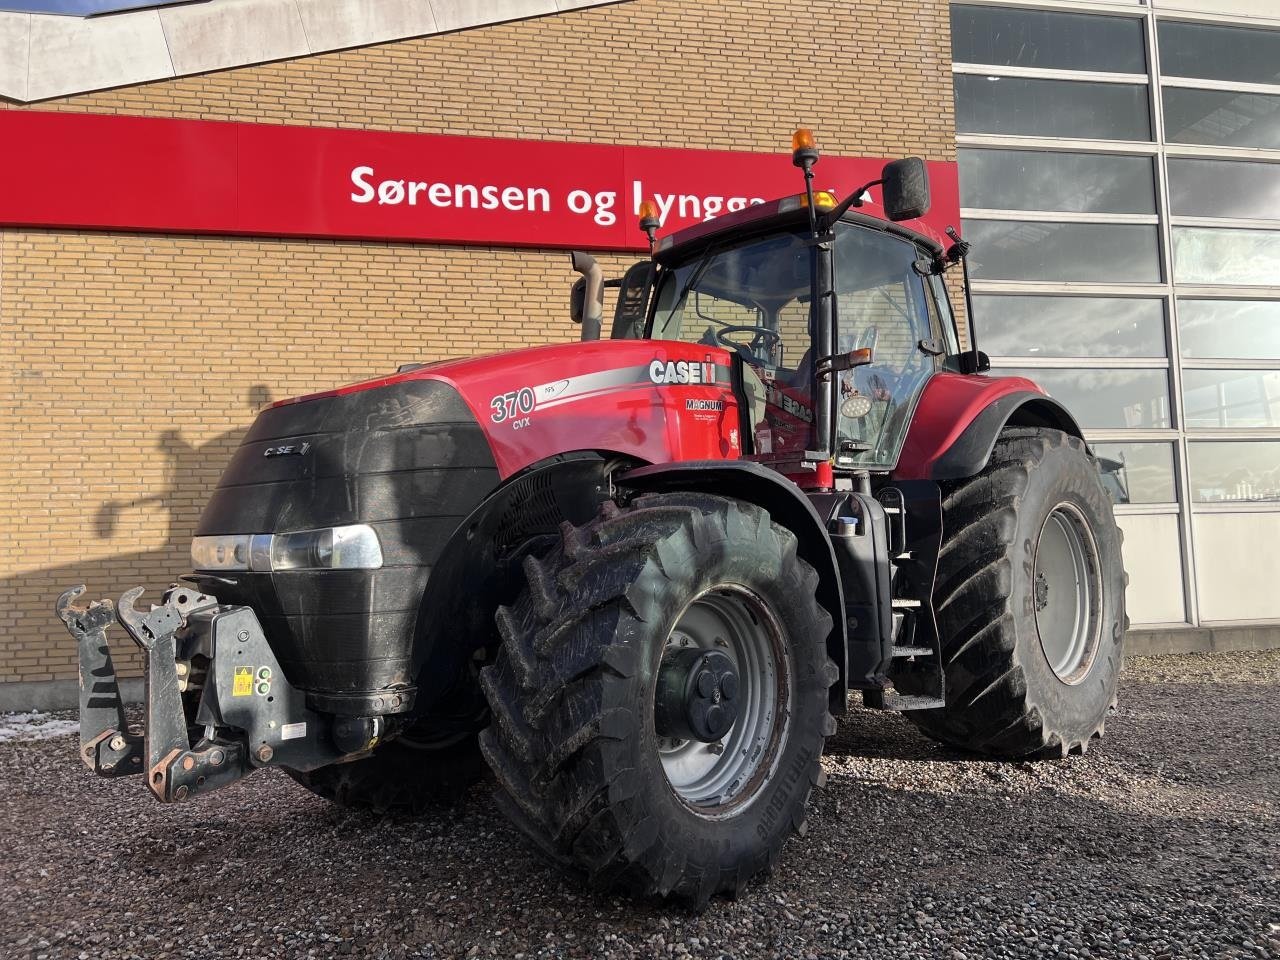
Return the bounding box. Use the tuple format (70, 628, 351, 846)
(906, 428, 1128, 759)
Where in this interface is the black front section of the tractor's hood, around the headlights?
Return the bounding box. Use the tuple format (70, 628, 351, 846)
(196, 380, 498, 703)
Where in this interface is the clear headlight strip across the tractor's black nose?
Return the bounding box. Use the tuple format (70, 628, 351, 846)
(191, 524, 383, 571)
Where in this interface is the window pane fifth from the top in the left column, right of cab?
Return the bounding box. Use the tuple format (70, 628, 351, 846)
(973, 296, 1166, 357)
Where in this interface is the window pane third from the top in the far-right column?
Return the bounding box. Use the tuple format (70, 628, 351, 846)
(1167, 157, 1280, 220)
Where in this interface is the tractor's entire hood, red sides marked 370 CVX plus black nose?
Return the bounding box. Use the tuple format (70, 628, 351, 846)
(196, 340, 740, 713)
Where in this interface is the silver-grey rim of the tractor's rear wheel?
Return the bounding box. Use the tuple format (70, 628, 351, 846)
(1032, 503, 1101, 684)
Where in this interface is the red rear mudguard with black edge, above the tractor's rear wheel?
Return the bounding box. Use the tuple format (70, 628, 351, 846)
(892, 374, 1084, 481)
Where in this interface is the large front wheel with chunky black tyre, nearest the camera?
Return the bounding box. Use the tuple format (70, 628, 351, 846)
(480, 493, 837, 908)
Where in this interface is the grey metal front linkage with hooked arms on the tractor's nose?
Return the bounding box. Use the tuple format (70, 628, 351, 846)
(58, 585, 373, 803)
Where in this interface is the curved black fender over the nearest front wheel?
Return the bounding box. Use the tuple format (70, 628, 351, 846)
(616, 461, 849, 713)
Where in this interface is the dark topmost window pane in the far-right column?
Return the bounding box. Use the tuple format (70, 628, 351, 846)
(1156, 20, 1280, 83)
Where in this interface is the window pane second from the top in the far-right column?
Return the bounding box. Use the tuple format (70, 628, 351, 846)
(1167, 87, 1280, 150)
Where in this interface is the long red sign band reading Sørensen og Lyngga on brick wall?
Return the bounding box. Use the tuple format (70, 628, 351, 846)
(0, 110, 960, 250)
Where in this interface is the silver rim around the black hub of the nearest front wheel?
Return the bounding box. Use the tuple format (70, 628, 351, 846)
(658, 585, 790, 818)
